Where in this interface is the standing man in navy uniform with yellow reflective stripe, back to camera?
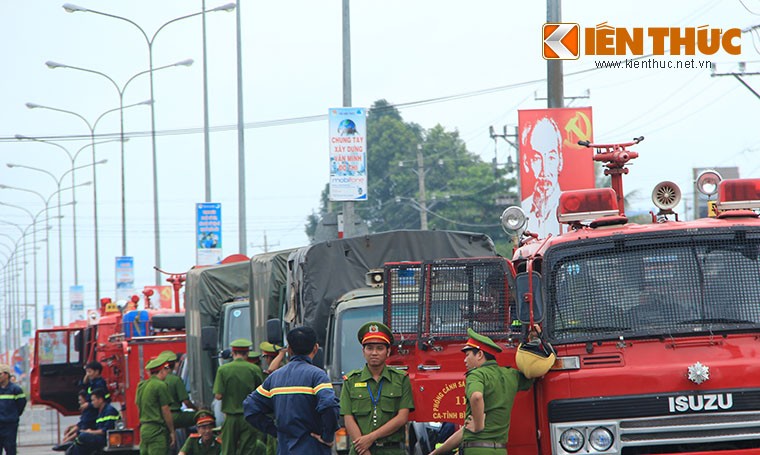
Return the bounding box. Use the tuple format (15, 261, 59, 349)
(243, 327, 339, 455)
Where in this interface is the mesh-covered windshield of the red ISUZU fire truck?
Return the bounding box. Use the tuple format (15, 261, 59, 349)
(544, 228, 760, 343)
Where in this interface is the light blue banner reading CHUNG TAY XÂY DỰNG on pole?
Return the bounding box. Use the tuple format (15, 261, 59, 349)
(328, 107, 367, 201)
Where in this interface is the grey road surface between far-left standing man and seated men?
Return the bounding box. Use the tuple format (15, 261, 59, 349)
(18, 405, 79, 455)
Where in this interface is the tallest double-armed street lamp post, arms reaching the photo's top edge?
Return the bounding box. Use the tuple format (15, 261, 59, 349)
(63, 3, 235, 284)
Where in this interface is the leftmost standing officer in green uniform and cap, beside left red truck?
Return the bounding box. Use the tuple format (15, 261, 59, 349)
(135, 355, 175, 455)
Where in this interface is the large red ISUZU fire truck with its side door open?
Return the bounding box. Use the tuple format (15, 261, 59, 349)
(384, 139, 760, 455)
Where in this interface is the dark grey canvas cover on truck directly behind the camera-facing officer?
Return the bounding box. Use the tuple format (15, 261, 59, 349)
(285, 230, 496, 345)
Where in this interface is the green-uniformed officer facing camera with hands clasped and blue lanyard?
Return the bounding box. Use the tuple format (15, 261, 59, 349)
(340, 322, 414, 455)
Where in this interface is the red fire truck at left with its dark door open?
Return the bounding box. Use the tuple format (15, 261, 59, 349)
(30, 279, 185, 452)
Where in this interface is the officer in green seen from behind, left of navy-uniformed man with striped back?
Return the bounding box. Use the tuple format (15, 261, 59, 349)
(214, 338, 264, 455)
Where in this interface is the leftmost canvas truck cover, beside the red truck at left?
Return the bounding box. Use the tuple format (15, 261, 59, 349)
(185, 261, 250, 405)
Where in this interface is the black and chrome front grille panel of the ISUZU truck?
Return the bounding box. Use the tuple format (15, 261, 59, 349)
(549, 389, 760, 455)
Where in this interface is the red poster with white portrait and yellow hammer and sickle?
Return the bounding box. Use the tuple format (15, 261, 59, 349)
(518, 107, 594, 237)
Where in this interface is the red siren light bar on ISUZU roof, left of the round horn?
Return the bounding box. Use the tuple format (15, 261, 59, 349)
(557, 188, 620, 223)
